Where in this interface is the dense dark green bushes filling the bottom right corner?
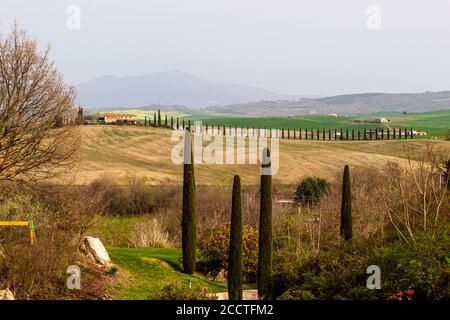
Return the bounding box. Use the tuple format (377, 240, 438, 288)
(274, 224, 450, 300)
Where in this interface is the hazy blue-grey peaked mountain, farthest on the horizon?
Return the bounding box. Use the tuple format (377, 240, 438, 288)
(76, 70, 302, 109)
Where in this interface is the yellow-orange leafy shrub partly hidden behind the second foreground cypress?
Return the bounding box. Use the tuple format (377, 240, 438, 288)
(199, 223, 258, 282)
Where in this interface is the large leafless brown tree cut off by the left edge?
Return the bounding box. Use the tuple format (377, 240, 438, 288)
(0, 26, 79, 182)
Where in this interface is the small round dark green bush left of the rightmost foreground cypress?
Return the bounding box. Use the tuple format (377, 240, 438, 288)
(295, 177, 330, 205)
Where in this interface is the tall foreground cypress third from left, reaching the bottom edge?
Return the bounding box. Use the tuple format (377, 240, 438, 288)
(257, 148, 273, 299)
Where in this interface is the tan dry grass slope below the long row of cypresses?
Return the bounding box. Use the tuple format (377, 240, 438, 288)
(77, 126, 450, 185)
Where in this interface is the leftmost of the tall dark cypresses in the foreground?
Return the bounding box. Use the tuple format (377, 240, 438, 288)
(181, 130, 197, 274)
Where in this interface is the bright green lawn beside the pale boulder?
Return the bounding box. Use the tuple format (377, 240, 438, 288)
(108, 248, 253, 300)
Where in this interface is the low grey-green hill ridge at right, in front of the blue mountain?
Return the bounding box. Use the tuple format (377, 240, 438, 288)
(208, 91, 450, 116)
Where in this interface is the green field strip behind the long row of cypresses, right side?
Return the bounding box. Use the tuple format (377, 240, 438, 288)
(194, 110, 450, 137)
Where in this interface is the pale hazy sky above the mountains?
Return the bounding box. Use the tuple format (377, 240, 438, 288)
(0, 0, 450, 95)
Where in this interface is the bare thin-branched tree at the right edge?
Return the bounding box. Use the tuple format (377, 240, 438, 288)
(383, 144, 449, 242)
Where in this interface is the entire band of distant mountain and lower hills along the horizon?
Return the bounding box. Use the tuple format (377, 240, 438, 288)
(76, 70, 450, 116)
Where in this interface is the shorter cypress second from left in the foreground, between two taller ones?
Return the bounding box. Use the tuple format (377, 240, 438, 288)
(228, 175, 244, 300)
